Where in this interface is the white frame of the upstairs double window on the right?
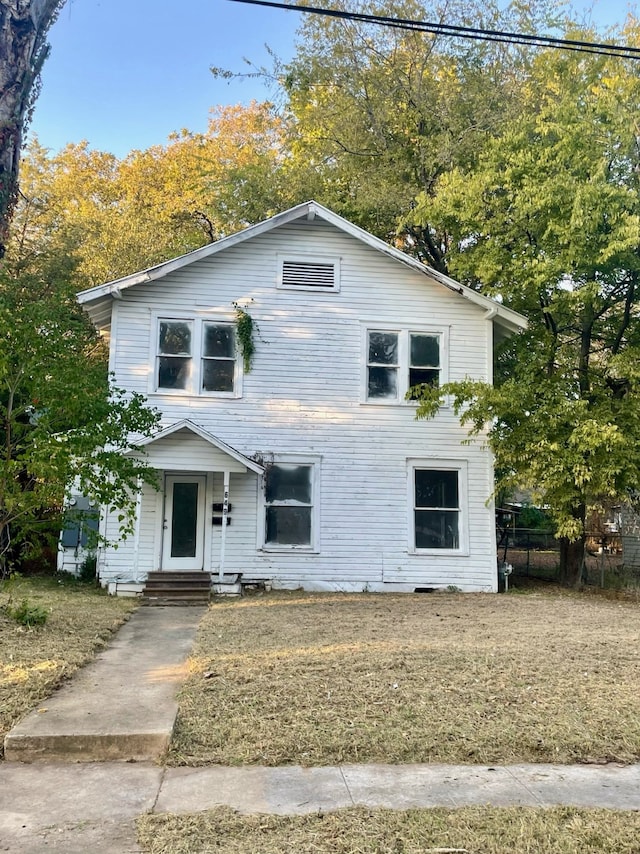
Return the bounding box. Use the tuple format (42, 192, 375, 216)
(360, 321, 449, 407)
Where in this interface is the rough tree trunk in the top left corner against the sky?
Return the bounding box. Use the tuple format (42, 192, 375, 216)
(0, 0, 65, 258)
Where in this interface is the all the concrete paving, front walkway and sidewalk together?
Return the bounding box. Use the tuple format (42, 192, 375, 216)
(0, 608, 640, 854)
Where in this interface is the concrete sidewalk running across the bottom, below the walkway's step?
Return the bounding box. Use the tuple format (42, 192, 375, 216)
(0, 762, 640, 854)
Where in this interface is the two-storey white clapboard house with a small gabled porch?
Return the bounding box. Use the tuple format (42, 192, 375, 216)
(63, 202, 525, 591)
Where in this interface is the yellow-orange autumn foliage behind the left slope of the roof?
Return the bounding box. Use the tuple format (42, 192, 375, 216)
(13, 103, 287, 289)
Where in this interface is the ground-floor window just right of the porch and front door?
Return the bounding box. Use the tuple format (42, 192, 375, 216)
(264, 462, 317, 549)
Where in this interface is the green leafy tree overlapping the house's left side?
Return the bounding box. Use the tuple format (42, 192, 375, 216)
(0, 241, 157, 574)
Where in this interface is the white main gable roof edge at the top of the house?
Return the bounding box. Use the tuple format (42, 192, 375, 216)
(78, 201, 527, 334)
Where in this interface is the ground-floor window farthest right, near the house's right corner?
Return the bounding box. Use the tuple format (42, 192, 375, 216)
(410, 461, 467, 551)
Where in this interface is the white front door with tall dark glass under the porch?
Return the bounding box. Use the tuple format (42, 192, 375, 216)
(162, 475, 206, 570)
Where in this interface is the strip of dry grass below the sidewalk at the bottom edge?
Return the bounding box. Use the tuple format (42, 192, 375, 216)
(138, 807, 640, 854)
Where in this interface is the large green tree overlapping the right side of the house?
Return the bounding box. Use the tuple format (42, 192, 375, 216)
(416, 31, 640, 585)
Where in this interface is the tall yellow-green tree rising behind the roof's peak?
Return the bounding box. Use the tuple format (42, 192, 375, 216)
(277, 0, 555, 272)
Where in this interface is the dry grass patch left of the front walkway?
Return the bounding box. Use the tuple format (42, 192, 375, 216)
(0, 579, 136, 745)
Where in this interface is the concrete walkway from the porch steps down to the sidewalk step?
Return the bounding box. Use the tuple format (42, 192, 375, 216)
(4, 606, 204, 762)
